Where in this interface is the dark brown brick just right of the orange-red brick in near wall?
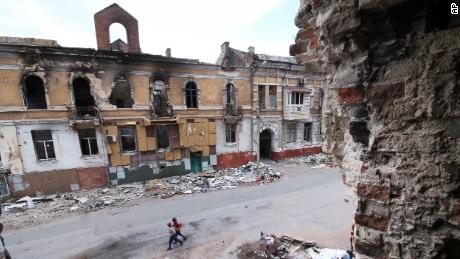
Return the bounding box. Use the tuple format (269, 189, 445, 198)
(367, 82, 404, 105)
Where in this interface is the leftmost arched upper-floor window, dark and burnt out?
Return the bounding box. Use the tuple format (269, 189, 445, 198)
(23, 75, 47, 109)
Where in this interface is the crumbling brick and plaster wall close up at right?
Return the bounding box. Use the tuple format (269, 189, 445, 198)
(291, 0, 460, 258)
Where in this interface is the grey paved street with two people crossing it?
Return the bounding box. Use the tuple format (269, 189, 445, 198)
(4, 164, 352, 259)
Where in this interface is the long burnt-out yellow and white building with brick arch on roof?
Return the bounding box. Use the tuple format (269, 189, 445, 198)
(0, 4, 323, 196)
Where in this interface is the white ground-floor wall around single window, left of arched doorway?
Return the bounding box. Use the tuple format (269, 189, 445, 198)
(216, 118, 252, 154)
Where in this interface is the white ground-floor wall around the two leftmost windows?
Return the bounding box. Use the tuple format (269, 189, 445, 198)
(17, 124, 107, 173)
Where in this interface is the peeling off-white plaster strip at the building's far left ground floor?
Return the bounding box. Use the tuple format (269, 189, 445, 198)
(0, 126, 23, 174)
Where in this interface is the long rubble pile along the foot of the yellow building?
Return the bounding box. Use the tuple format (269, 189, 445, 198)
(2, 162, 281, 231)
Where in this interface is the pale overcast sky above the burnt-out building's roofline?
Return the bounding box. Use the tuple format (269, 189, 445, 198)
(0, 0, 299, 63)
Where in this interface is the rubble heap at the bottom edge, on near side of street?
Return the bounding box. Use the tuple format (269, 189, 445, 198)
(234, 235, 353, 259)
